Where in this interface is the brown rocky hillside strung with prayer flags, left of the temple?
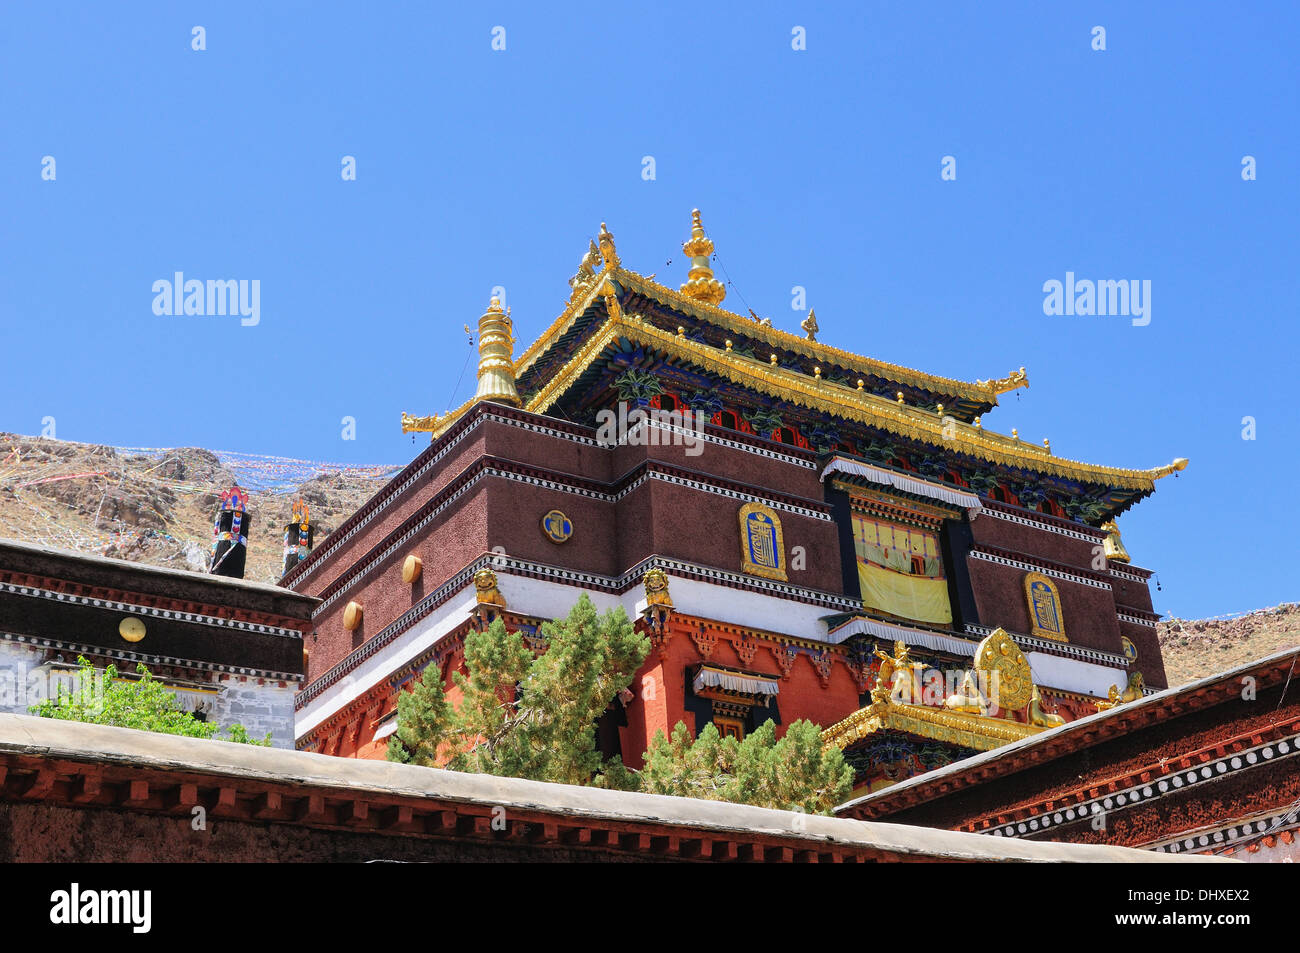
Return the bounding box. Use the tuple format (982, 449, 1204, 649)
(0, 433, 398, 582)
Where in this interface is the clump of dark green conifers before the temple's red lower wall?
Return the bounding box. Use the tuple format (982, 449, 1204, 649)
(387, 594, 853, 814)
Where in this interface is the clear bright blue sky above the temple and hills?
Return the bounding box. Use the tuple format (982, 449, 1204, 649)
(0, 3, 1300, 616)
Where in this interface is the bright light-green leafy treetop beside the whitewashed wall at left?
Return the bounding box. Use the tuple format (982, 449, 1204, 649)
(27, 657, 270, 748)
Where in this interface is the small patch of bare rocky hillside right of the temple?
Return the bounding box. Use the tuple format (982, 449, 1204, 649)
(1158, 602, 1300, 685)
